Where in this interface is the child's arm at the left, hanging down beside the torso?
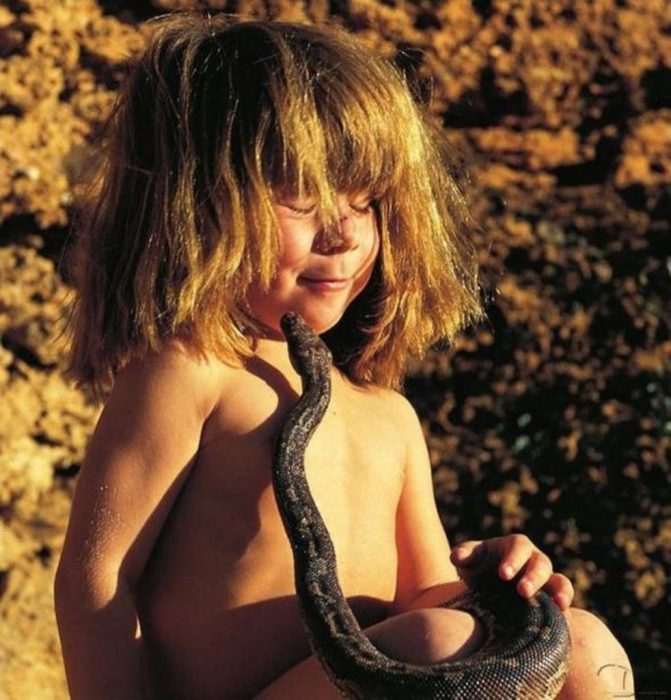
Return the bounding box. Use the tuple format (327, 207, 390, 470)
(55, 347, 219, 700)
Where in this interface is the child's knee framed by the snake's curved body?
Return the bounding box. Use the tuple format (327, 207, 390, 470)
(367, 608, 483, 664)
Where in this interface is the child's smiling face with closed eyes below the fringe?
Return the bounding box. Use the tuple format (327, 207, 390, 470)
(247, 193, 379, 336)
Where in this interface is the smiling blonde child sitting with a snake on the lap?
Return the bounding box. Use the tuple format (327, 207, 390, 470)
(56, 14, 630, 700)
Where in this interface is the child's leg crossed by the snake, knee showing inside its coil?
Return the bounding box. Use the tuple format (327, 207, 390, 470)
(255, 608, 481, 700)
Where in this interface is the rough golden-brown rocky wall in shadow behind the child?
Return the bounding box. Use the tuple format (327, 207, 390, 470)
(0, 0, 671, 700)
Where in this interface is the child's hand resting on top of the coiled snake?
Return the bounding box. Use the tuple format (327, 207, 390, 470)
(450, 535, 573, 610)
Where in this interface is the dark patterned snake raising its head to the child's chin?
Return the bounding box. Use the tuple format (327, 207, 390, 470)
(271, 312, 570, 700)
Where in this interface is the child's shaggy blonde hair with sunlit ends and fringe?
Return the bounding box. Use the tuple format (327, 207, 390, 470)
(69, 13, 481, 395)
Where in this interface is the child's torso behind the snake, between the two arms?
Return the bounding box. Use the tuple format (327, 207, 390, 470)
(138, 357, 404, 697)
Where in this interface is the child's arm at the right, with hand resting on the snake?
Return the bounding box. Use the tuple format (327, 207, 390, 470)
(394, 399, 573, 612)
